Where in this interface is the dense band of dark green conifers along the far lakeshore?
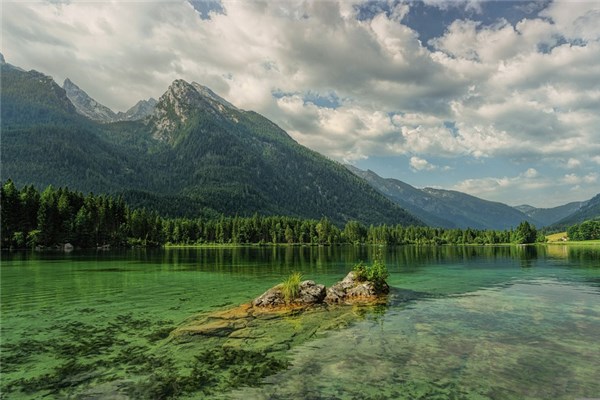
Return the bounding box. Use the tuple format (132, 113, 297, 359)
(0, 179, 544, 248)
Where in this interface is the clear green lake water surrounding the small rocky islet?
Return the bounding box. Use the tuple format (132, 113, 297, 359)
(0, 246, 600, 399)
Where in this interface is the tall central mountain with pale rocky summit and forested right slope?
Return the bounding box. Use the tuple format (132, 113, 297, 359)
(135, 80, 419, 224)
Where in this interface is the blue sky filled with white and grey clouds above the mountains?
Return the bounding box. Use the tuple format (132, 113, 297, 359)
(0, 0, 600, 207)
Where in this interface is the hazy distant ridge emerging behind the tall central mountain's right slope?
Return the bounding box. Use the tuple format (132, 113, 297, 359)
(347, 166, 539, 229)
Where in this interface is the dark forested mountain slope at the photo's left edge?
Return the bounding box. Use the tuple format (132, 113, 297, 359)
(0, 64, 155, 193)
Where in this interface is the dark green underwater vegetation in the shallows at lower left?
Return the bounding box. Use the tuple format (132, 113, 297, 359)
(0, 314, 288, 399)
